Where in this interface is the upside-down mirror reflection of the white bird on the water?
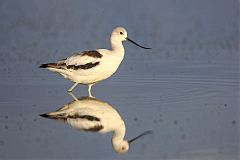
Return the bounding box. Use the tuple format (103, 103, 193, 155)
(41, 93, 151, 153)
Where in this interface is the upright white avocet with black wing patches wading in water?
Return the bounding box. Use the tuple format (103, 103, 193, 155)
(40, 27, 151, 97)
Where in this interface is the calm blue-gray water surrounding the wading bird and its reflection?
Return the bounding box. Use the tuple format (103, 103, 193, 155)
(0, 0, 239, 160)
